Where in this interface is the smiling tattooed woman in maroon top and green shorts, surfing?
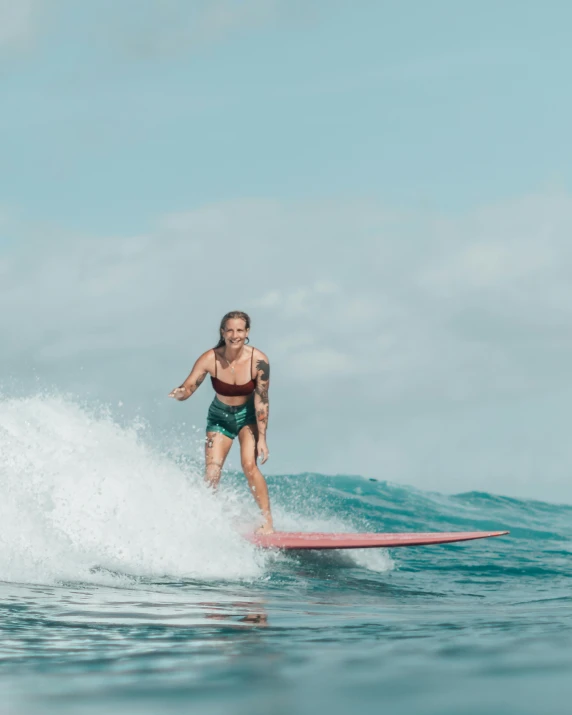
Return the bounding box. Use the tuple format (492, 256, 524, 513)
(169, 310, 274, 534)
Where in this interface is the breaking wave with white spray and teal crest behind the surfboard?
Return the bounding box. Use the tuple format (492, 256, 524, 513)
(0, 396, 572, 583)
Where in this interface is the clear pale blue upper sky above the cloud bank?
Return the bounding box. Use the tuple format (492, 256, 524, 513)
(0, 0, 572, 232)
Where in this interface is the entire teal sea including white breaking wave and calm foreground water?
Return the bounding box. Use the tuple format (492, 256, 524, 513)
(0, 397, 572, 715)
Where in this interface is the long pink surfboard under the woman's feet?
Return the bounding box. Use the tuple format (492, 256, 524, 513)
(246, 531, 509, 550)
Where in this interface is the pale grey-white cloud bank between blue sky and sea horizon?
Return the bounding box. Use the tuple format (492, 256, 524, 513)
(0, 195, 572, 499)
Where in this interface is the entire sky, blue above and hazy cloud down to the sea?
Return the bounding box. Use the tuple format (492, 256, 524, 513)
(0, 0, 572, 503)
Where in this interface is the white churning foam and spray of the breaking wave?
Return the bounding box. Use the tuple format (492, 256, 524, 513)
(0, 396, 392, 583)
